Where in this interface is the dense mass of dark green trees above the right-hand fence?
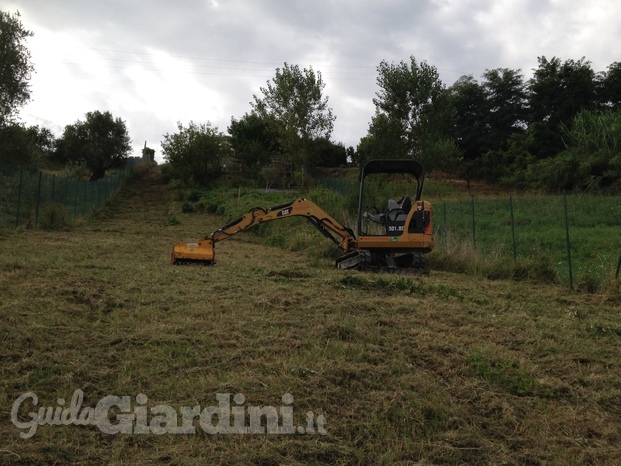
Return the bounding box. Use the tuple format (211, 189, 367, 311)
(448, 57, 621, 191)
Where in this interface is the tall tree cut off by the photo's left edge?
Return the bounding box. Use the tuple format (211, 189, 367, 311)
(0, 11, 34, 126)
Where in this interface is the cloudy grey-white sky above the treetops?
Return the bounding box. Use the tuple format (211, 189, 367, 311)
(0, 0, 621, 160)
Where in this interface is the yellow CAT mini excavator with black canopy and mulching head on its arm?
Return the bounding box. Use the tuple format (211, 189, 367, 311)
(172, 159, 434, 271)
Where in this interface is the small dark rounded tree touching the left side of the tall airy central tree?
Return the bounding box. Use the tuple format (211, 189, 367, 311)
(228, 112, 281, 174)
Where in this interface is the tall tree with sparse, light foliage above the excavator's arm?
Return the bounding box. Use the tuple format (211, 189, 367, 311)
(250, 63, 336, 169)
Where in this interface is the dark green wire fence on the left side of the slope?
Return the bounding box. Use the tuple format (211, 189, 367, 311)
(0, 158, 141, 228)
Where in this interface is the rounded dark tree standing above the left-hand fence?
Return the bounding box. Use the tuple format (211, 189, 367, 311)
(57, 110, 131, 181)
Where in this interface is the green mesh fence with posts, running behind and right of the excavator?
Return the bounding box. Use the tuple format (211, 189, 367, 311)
(321, 179, 621, 286)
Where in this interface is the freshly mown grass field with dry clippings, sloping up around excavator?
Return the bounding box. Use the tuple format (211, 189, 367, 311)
(0, 167, 621, 465)
